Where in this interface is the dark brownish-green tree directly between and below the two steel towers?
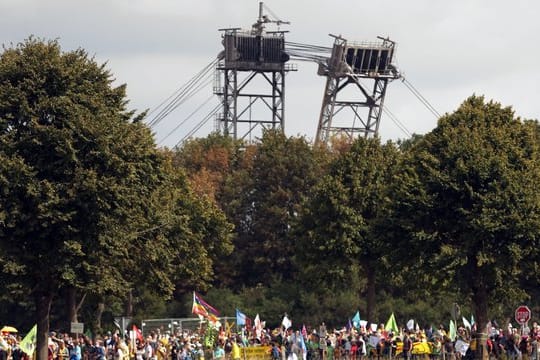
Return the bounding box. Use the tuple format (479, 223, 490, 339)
(219, 130, 320, 286)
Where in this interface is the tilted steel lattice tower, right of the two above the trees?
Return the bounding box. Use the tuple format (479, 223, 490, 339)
(315, 36, 400, 143)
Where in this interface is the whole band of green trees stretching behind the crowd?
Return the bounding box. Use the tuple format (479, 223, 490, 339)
(0, 38, 540, 358)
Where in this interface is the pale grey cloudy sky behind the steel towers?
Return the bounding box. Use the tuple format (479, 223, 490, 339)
(0, 0, 540, 146)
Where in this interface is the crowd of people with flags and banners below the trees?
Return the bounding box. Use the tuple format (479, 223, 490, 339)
(0, 323, 540, 360)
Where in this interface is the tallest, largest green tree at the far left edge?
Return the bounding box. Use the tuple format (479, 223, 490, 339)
(0, 38, 231, 359)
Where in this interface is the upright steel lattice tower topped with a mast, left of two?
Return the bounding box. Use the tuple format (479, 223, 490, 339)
(214, 3, 295, 139)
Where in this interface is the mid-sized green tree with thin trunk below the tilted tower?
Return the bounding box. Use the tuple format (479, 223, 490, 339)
(295, 138, 399, 319)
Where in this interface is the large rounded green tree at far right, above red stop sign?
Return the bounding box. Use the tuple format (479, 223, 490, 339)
(394, 96, 540, 332)
